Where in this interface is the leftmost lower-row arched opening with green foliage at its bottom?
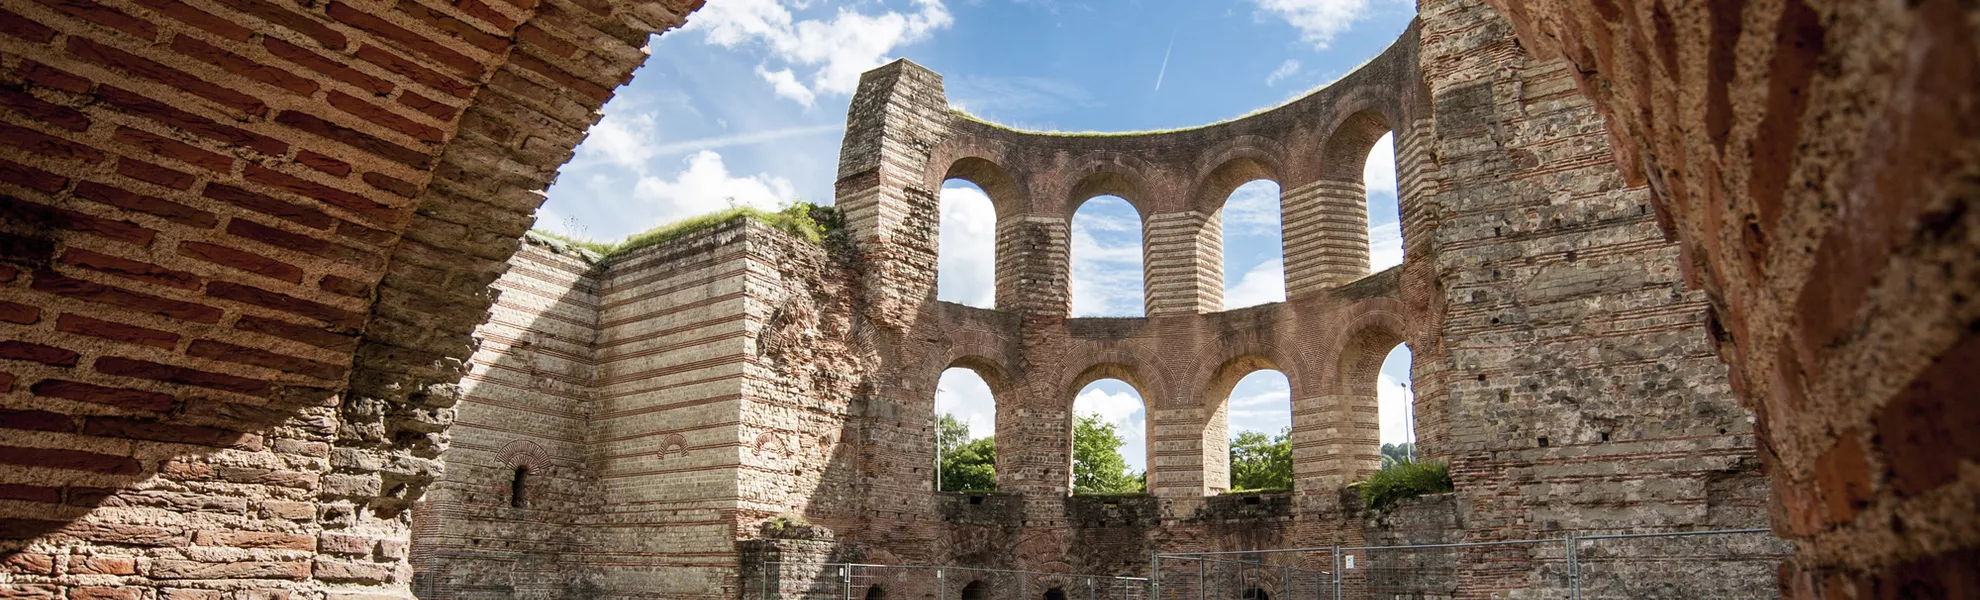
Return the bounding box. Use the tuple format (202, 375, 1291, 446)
(935, 360, 996, 491)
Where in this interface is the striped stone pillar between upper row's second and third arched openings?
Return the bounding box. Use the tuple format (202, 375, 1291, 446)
(1142, 210, 1224, 317)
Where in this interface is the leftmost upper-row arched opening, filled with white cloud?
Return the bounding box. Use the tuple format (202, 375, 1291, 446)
(935, 186, 996, 309)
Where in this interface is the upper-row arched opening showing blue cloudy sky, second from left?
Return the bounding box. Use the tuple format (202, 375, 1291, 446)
(1069, 196, 1146, 317)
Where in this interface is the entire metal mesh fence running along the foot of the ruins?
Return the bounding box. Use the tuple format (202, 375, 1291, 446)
(744, 529, 1794, 600)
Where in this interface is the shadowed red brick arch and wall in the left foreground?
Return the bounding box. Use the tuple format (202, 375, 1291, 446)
(0, 0, 699, 598)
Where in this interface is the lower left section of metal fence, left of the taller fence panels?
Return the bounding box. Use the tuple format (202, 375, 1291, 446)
(754, 562, 1148, 600)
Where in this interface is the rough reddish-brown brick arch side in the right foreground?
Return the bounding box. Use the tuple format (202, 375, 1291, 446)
(1491, 0, 1980, 598)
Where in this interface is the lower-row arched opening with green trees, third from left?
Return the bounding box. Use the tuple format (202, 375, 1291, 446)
(1224, 368, 1293, 491)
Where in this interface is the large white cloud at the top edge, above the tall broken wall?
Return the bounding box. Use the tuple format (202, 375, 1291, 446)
(687, 0, 954, 105)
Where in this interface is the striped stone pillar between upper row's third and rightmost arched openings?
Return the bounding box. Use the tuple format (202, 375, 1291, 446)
(1279, 180, 1368, 297)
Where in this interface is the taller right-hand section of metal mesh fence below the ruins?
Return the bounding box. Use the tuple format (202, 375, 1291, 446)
(1150, 529, 1792, 600)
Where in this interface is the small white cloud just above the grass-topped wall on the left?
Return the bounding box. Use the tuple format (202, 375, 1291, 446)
(634, 150, 796, 224)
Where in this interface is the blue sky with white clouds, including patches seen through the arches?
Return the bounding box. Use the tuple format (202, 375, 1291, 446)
(537, 0, 1414, 479)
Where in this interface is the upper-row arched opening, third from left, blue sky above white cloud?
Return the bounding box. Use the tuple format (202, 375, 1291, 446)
(1220, 178, 1285, 309)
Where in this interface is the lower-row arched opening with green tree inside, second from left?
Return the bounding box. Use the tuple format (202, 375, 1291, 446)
(1069, 378, 1148, 495)
